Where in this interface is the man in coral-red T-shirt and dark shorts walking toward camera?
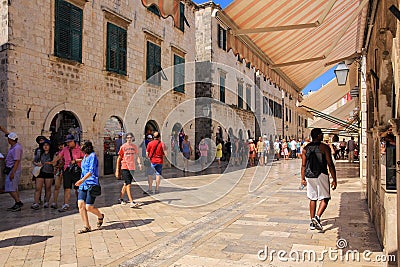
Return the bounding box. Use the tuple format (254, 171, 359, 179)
(115, 133, 142, 208)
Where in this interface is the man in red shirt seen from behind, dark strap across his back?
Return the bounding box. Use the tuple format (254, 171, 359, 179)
(146, 132, 166, 194)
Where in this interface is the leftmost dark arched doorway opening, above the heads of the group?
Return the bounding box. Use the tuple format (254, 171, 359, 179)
(49, 110, 82, 147)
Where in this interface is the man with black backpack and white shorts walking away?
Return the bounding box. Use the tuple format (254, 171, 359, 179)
(301, 128, 337, 231)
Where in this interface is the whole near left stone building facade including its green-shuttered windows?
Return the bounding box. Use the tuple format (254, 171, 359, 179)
(0, 0, 195, 187)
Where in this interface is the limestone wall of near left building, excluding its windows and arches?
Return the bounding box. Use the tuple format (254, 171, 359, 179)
(0, 0, 195, 187)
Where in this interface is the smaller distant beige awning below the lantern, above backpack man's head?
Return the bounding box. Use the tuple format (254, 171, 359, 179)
(309, 99, 358, 131)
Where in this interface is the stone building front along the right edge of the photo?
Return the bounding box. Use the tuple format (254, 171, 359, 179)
(359, 0, 400, 260)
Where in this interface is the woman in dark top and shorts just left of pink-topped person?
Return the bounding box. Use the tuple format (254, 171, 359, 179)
(31, 139, 54, 210)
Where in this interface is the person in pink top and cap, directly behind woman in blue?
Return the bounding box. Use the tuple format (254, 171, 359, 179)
(46, 134, 85, 212)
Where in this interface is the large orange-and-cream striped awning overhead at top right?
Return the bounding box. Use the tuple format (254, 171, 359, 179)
(224, 0, 369, 88)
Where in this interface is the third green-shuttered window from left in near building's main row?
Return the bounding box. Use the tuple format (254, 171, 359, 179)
(146, 41, 161, 85)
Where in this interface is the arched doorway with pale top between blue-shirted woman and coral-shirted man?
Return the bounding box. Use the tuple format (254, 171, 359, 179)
(103, 116, 125, 175)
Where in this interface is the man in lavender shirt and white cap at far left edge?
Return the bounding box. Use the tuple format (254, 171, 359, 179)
(0, 126, 24, 211)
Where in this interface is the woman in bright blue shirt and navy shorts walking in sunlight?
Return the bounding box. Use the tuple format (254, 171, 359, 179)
(75, 141, 104, 234)
